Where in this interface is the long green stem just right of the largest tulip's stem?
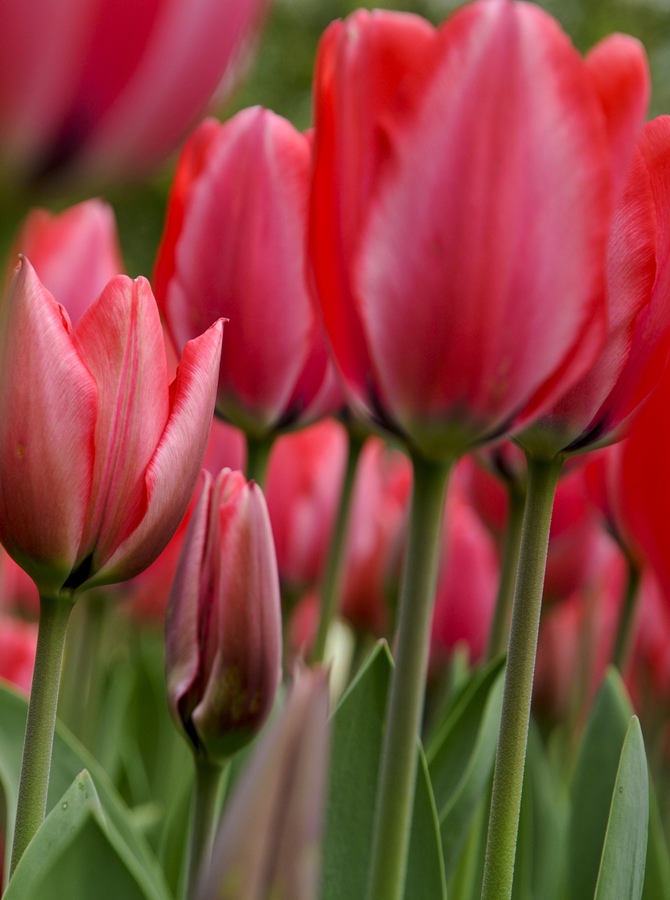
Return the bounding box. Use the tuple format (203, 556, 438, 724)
(482, 457, 563, 900)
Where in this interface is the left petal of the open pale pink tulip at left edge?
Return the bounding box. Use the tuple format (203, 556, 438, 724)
(0, 260, 98, 593)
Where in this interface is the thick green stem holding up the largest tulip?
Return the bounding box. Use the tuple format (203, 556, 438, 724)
(367, 458, 450, 900)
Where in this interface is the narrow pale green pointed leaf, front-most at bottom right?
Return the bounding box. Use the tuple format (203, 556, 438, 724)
(594, 716, 649, 900)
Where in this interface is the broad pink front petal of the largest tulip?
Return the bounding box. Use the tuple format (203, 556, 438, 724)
(356, 2, 611, 456)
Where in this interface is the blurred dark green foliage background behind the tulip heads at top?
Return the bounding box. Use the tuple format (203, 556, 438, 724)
(0, 0, 670, 276)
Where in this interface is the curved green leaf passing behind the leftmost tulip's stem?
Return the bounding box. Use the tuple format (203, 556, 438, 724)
(0, 684, 170, 898)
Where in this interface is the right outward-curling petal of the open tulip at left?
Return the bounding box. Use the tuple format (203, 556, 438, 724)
(94, 321, 223, 586)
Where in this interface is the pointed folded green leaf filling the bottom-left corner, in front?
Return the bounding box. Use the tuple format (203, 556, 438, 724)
(4, 770, 159, 900)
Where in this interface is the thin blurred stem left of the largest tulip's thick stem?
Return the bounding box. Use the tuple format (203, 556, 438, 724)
(311, 432, 363, 663)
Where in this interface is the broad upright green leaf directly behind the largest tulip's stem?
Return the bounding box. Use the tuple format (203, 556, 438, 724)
(322, 642, 446, 900)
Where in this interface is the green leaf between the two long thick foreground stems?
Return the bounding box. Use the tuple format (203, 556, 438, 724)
(428, 661, 504, 877)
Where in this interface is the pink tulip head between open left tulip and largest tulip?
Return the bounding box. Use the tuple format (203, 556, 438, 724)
(155, 108, 342, 438)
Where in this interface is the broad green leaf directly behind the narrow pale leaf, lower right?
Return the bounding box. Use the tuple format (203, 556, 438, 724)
(568, 668, 633, 900)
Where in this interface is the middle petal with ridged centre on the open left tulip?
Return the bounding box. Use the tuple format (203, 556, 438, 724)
(74, 276, 169, 568)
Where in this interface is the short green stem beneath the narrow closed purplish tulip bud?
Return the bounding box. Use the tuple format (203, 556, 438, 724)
(184, 759, 225, 900)
